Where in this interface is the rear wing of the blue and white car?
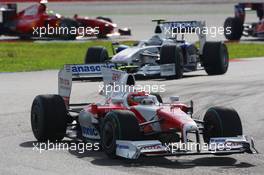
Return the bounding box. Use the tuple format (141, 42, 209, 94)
(156, 20, 206, 53)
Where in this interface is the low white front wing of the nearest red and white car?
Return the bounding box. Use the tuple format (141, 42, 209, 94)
(116, 136, 258, 159)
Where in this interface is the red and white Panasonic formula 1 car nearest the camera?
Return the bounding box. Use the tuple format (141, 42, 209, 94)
(31, 65, 257, 159)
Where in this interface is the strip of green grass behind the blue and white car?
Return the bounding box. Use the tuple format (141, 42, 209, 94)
(0, 41, 264, 72)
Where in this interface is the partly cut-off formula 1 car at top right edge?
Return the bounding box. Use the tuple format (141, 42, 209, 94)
(224, 3, 264, 40)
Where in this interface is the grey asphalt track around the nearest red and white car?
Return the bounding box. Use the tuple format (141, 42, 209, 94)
(0, 58, 264, 175)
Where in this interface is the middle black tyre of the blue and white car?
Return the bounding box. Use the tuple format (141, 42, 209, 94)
(160, 44, 183, 79)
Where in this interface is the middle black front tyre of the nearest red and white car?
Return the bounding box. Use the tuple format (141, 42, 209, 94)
(101, 110, 141, 158)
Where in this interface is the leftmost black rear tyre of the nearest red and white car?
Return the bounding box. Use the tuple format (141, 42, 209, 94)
(31, 95, 67, 141)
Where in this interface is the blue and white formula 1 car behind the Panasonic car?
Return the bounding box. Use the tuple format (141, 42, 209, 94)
(85, 20, 229, 79)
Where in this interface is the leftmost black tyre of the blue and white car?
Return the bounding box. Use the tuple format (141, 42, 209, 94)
(84, 46, 109, 64)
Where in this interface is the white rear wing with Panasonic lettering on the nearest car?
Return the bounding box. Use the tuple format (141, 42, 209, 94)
(58, 63, 135, 109)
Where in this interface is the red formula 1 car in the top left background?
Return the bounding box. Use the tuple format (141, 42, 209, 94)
(0, 3, 131, 39)
